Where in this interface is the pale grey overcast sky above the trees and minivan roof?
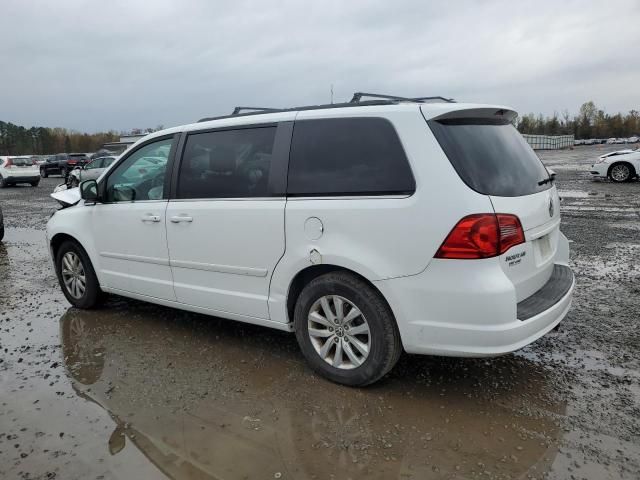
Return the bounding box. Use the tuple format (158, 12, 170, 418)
(0, 0, 640, 132)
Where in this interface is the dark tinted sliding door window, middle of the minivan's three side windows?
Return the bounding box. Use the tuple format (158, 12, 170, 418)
(177, 127, 276, 198)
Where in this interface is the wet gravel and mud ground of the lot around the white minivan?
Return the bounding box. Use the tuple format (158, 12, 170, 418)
(0, 146, 640, 479)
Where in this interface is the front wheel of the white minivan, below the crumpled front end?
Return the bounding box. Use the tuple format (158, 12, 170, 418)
(56, 241, 102, 309)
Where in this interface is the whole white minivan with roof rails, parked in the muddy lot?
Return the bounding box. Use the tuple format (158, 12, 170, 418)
(47, 94, 574, 385)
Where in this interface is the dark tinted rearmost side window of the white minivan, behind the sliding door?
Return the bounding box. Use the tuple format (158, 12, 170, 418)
(287, 118, 416, 196)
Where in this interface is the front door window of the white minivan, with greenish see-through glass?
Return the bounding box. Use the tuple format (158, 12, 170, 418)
(106, 138, 173, 202)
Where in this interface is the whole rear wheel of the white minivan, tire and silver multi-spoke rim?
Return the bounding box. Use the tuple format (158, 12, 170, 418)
(294, 272, 402, 386)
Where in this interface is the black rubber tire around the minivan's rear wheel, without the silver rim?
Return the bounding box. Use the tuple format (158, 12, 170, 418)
(294, 272, 402, 387)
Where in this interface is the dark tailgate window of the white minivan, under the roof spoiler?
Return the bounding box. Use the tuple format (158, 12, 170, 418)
(429, 118, 551, 197)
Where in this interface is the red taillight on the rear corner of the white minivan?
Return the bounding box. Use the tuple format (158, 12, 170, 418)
(435, 213, 524, 259)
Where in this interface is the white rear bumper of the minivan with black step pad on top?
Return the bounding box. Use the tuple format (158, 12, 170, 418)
(374, 233, 575, 357)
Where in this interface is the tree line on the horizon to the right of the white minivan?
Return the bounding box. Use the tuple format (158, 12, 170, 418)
(516, 101, 640, 139)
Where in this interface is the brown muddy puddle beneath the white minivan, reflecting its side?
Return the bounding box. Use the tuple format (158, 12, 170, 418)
(61, 301, 564, 479)
